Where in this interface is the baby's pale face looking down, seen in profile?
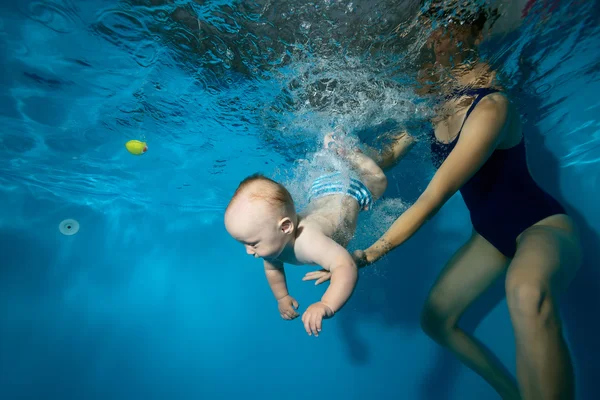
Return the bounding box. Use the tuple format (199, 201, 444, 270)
(225, 199, 291, 260)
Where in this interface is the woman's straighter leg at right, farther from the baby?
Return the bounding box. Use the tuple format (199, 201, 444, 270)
(506, 216, 581, 400)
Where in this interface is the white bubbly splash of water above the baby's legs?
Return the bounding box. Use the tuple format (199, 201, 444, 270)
(263, 56, 429, 157)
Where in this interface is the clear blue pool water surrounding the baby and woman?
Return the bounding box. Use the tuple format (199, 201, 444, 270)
(0, 0, 600, 400)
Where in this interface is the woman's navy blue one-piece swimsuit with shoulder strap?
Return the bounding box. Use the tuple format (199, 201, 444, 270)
(431, 88, 566, 258)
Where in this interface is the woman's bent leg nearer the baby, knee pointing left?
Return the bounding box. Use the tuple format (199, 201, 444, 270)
(421, 232, 520, 399)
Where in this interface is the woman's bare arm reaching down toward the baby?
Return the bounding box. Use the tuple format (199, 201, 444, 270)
(363, 94, 508, 263)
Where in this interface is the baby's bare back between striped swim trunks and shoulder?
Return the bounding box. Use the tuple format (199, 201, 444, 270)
(300, 194, 359, 247)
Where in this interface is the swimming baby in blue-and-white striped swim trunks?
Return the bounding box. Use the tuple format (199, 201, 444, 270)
(225, 130, 413, 336)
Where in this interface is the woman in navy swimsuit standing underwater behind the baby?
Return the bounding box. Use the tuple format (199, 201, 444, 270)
(305, 3, 581, 399)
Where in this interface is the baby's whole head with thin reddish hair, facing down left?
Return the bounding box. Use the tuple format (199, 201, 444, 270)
(225, 174, 298, 259)
